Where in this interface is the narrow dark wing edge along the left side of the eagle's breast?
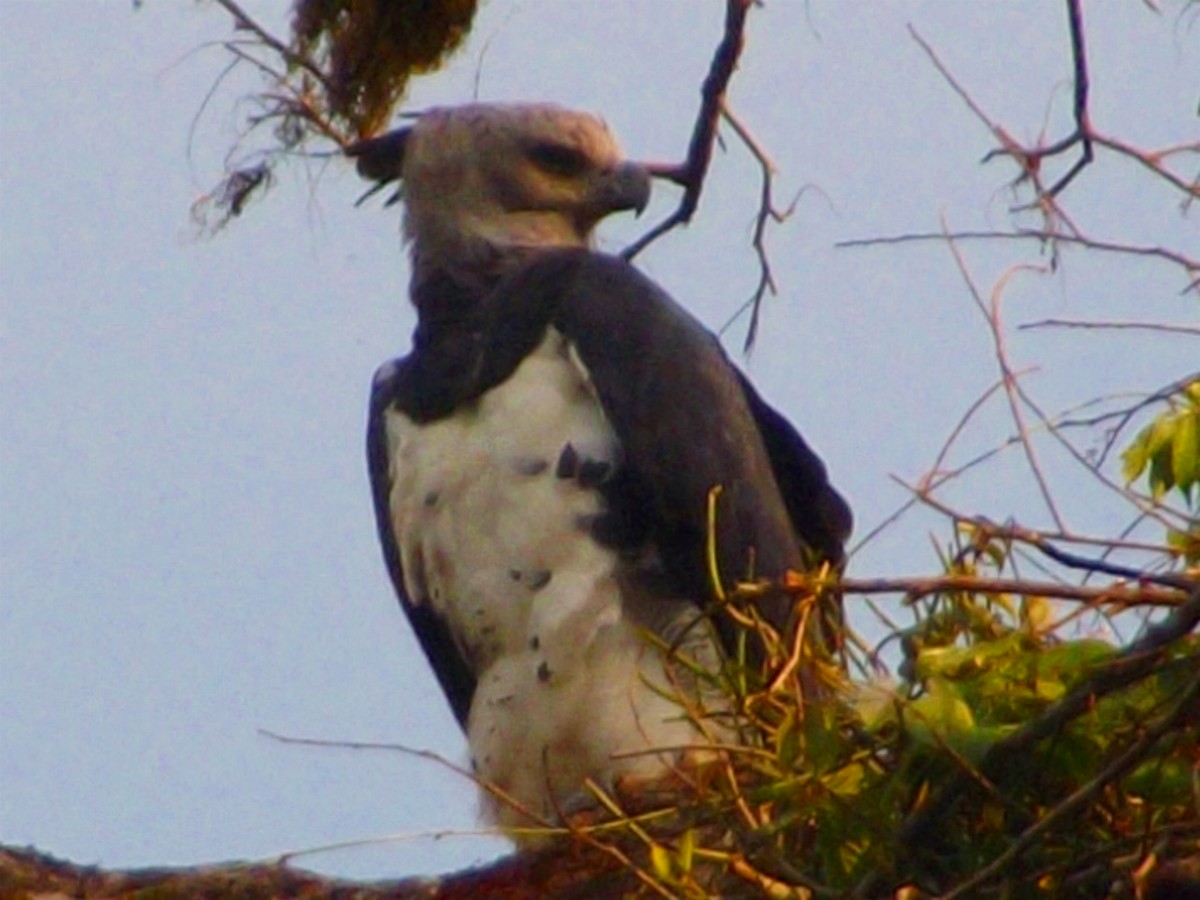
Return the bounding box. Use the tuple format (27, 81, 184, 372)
(367, 359, 475, 728)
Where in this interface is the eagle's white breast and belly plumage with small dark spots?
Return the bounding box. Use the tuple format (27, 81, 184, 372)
(386, 329, 718, 826)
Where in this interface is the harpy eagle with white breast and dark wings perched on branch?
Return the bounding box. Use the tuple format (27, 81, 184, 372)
(348, 104, 851, 840)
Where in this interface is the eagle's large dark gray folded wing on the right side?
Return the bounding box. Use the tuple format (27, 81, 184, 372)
(494, 251, 850, 643)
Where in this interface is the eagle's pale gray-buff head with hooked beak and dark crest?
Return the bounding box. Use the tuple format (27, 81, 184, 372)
(347, 103, 650, 290)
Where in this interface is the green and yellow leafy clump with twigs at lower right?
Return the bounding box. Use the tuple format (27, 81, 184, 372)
(573, 580, 1200, 898)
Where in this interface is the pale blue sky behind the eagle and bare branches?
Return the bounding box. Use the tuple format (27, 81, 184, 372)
(0, 0, 1200, 876)
